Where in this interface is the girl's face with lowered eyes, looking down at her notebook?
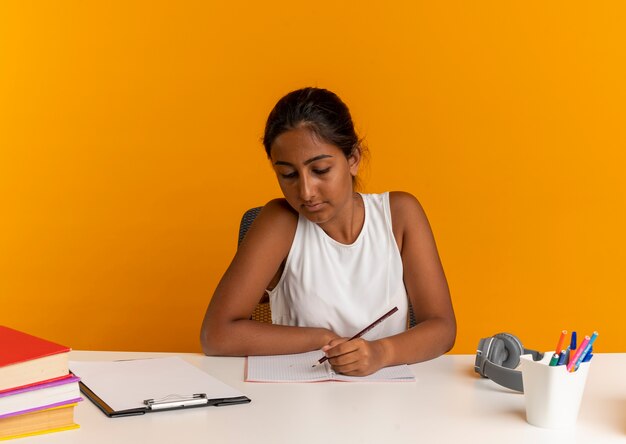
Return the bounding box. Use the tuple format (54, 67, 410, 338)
(270, 128, 360, 225)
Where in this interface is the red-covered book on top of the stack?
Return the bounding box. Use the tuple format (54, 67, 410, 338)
(0, 325, 70, 391)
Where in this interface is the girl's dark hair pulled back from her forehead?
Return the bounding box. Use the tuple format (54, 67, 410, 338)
(263, 88, 361, 158)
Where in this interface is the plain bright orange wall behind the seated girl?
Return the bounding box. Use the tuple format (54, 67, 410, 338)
(0, 0, 626, 353)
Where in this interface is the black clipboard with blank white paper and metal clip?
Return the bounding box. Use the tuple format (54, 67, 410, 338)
(70, 357, 251, 418)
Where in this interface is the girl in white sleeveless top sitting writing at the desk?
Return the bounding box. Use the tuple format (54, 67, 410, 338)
(201, 88, 456, 375)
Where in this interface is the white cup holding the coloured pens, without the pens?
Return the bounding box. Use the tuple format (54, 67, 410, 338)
(521, 352, 589, 429)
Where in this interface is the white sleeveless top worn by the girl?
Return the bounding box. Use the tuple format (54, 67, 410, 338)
(269, 193, 408, 340)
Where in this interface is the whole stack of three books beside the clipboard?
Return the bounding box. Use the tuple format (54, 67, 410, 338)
(0, 326, 82, 440)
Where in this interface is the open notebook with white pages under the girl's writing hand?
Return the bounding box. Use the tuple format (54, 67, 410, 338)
(245, 351, 415, 382)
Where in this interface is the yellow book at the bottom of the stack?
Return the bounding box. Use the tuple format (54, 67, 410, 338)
(0, 404, 79, 441)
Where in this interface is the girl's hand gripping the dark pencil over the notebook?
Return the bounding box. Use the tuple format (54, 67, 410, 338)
(322, 338, 385, 376)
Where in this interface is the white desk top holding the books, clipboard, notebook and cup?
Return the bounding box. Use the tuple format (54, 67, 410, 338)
(29, 351, 626, 444)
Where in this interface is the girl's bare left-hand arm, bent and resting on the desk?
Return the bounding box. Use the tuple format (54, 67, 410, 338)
(200, 199, 337, 356)
